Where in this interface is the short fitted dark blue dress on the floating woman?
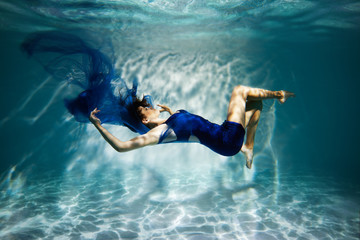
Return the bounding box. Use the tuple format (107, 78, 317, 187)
(159, 110, 245, 156)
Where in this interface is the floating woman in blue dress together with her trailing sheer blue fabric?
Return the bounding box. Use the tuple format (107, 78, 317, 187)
(22, 31, 295, 168)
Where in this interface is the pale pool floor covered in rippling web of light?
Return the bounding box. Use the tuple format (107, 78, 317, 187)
(0, 165, 359, 239)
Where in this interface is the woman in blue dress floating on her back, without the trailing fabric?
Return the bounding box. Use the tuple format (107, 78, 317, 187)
(89, 85, 295, 169)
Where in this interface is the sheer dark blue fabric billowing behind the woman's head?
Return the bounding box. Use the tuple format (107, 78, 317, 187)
(22, 31, 152, 134)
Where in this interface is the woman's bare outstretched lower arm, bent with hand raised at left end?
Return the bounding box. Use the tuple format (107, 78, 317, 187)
(89, 108, 160, 152)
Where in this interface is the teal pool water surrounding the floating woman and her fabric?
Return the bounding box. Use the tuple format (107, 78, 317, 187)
(0, 0, 360, 239)
